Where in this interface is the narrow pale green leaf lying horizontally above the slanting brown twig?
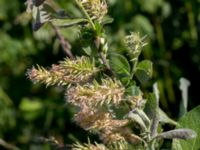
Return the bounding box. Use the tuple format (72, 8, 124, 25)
(50, 18, 87, 27)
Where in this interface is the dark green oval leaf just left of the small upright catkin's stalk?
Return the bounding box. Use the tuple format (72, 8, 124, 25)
(110, 53, 131, 82)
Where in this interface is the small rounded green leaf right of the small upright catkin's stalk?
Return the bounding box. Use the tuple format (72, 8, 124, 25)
(136, 60, 153, 83)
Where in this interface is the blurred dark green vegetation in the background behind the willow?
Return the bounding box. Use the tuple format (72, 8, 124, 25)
(0, 0, 200, 150)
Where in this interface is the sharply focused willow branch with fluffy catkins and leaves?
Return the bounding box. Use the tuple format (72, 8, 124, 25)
(26, 0, 196, 150)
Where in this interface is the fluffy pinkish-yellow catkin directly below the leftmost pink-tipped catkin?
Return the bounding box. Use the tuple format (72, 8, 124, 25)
(66, 78, 125, 107)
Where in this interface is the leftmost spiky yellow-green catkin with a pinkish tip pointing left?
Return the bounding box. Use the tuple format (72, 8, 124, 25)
(27, 57, 98, 86)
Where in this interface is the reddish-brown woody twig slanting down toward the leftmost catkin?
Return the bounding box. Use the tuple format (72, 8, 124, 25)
(50, 23, 74, 59)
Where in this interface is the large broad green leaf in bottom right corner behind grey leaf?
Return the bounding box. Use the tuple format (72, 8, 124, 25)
(172, 106, 200, 150)
